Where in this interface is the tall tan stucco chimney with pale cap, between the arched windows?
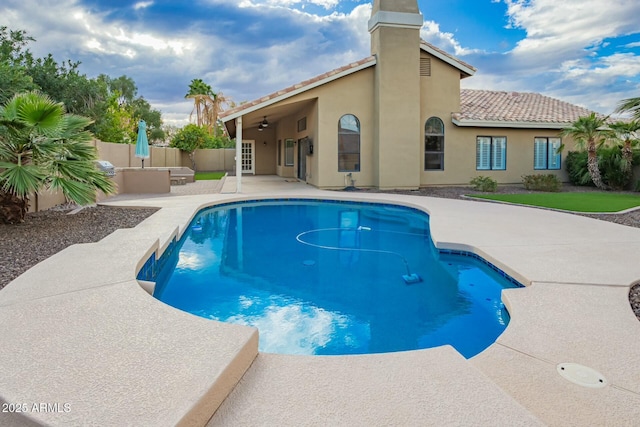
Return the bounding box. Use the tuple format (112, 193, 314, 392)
(369, 0, 423, 189)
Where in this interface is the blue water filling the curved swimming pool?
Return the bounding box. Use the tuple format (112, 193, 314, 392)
(154, 200, 518, 358)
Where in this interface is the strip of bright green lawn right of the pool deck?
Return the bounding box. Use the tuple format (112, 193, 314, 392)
(469, 192, 640, 212)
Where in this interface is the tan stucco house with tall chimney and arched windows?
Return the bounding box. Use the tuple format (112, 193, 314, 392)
(221, 0, 591, 189)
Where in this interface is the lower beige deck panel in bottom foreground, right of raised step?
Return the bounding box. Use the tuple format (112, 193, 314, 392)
(207, 346, 543, 427)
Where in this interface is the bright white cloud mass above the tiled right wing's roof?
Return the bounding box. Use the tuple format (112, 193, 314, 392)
(462, 0, 640, 113)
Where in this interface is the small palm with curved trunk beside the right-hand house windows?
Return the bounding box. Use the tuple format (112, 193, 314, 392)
(562, 113, 611, 190)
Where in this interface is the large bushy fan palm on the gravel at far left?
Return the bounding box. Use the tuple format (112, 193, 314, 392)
(0, 92, 115, 223)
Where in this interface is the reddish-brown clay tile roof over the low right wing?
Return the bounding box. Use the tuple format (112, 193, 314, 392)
(453, 89, 592, 126)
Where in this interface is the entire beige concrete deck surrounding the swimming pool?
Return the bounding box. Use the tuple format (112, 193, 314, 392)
(0, 177, 640, 426)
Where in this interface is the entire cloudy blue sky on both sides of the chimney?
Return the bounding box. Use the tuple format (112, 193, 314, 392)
(0, 0, 640, 125)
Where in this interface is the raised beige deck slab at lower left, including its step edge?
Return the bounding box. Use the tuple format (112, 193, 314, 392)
(0, 277, 258, 426)
